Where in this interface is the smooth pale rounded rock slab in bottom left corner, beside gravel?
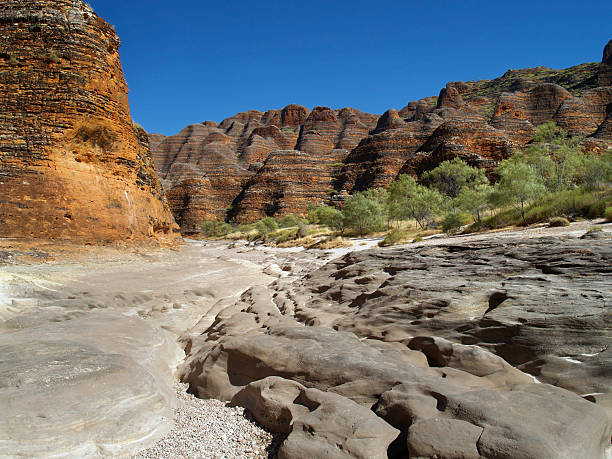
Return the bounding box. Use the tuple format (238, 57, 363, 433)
(0, 308, 174, 457)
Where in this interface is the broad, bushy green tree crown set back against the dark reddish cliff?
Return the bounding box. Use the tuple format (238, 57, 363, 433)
(421, 158, 489, 199)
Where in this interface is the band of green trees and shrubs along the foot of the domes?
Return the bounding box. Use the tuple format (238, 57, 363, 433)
(202, 122, 612, 245)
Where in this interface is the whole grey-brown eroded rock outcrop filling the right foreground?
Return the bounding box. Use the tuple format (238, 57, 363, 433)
(180, 233, 612, 458)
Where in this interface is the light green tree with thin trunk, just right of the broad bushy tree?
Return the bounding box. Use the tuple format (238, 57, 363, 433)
(491, 155, 546, 220)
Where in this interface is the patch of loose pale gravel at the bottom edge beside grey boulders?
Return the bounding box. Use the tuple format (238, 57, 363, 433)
(134, 383, 282, 459)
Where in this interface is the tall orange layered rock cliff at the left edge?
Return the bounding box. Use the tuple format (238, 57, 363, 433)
(0, 0, 176, 241)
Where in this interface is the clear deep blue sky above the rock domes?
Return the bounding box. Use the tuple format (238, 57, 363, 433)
(89, 0, 612, 135)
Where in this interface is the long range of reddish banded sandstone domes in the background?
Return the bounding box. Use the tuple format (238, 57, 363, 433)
(150, 42, 612, 233)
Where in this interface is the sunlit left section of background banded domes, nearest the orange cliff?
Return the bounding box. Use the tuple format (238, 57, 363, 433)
(151, 105, 378, 230)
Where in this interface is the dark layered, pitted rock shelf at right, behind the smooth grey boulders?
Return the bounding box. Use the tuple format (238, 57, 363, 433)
(278, 238, 612, 394)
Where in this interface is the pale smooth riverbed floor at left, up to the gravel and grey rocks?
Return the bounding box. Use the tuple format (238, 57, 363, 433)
(0, 244, 278, 457)
